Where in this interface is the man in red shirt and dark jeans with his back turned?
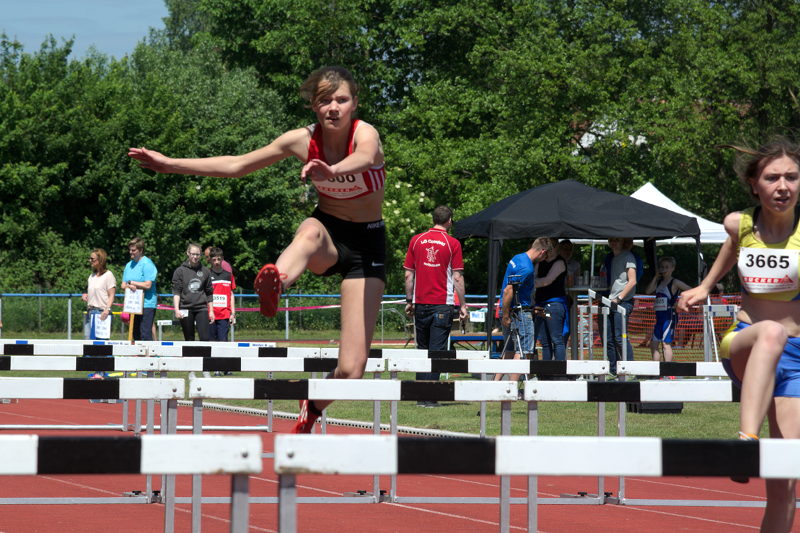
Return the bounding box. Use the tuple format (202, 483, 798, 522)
(403, 205, 467, 407)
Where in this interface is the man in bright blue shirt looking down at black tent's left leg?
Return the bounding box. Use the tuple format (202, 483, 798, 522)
(494, 237, 553, 381)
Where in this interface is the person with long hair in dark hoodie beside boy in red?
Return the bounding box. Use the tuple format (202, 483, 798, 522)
(172, 243, 214, 341)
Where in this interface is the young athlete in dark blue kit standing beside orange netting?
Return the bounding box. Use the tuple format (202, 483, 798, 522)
(647, 257, 691, 362)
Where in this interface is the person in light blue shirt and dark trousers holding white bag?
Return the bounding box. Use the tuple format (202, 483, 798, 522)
(120, 237, 158, 341)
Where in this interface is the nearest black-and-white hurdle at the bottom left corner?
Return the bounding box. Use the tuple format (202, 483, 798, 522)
(0, 435, 262, 533)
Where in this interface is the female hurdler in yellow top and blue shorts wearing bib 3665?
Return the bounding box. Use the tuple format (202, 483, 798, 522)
(678, 139, 800, 532)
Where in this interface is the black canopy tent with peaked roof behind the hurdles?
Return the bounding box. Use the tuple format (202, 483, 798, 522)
(453, 180, 700, 336)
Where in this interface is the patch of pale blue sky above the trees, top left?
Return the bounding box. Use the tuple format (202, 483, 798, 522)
(0, 0, 167, 59)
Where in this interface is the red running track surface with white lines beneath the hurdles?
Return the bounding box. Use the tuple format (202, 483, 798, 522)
(0, 400, 798, 533)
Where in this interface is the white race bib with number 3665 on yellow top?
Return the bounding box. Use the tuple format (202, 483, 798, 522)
(738, 248, 800, 294)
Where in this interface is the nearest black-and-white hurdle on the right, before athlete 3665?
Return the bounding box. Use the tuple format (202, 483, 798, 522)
(274, 435, 800, 533)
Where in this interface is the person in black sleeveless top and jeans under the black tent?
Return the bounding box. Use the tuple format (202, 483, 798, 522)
(534, 239, 569, 361)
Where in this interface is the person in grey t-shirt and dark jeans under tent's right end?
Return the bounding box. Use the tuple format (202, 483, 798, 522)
(605, 237, 636, 376)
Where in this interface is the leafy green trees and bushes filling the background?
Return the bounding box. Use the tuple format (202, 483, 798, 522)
(0, 0, 800, 293)
